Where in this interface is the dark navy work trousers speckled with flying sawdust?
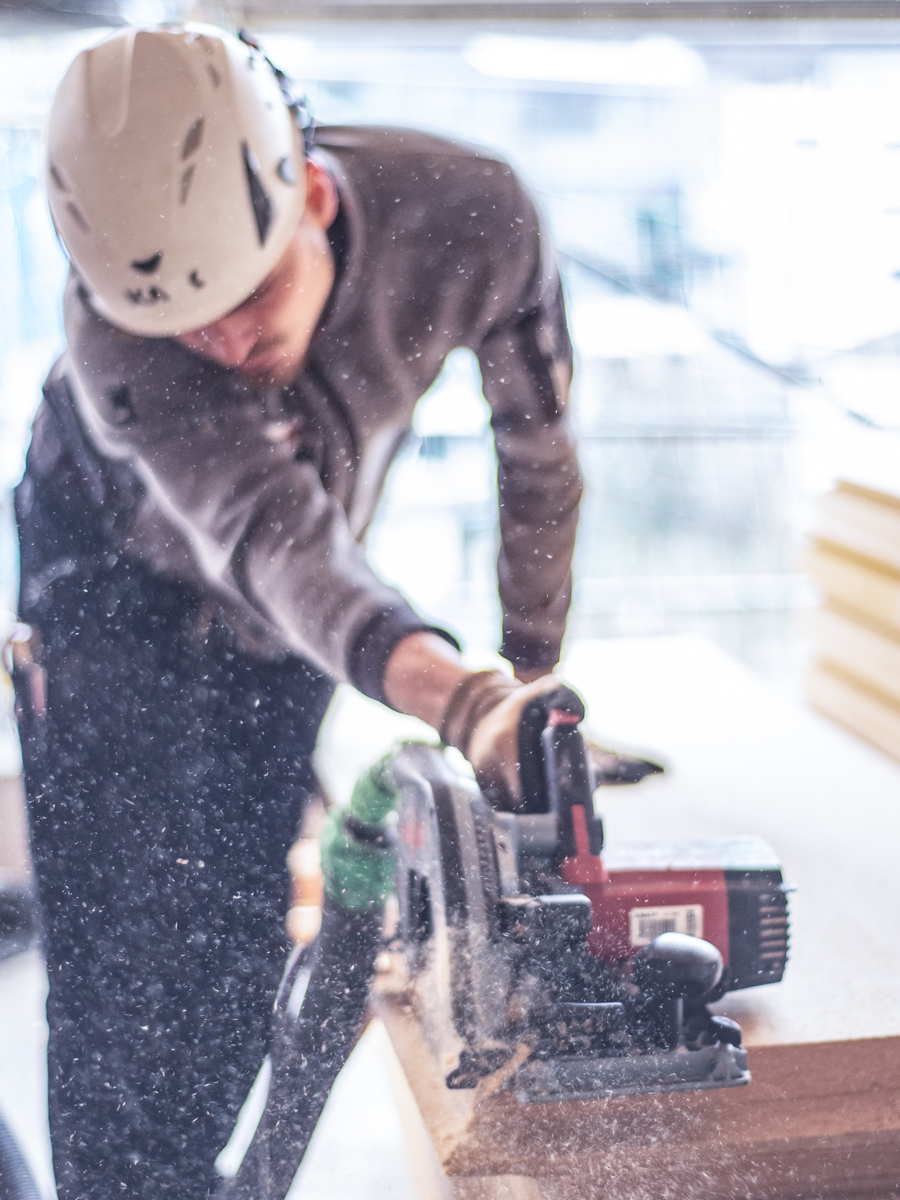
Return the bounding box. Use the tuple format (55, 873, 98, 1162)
(19, 560, 334, 1200)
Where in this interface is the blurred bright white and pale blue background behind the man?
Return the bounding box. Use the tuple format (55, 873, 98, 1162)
(0, 5, 900, 696)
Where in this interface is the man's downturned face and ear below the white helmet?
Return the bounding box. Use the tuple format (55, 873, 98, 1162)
(178, 162, 337, 385)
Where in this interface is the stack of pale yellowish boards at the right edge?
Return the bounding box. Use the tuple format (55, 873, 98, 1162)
(808, 481, 900, 758)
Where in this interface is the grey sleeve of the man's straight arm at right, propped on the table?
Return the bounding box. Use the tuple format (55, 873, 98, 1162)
(478, 192, 582, 670)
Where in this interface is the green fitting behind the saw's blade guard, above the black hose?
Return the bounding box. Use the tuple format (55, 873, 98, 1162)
(320, 755, 400, 913)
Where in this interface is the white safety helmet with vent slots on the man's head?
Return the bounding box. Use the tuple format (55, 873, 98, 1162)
(46, 25, 306, 337)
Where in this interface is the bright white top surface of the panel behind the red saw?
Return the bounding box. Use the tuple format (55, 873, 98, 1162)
(564, 637, 900, 1045)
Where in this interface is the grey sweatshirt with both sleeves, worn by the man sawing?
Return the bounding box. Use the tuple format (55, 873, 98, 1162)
(24, 127, 581, 698)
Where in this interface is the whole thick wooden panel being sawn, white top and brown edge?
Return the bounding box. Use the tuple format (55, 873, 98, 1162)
(355, 637, 900, 1200)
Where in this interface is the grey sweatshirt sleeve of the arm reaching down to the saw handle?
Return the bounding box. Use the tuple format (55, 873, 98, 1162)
(60, 279, 440, 701)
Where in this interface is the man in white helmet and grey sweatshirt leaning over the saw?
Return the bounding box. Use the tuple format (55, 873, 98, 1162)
(17, 26, 581, 1200)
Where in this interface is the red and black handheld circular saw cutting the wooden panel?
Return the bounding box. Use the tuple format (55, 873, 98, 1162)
(391, 688, 788, 1102)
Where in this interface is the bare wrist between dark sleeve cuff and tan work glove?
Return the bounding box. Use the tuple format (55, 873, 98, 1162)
(384, 632, 470, 730)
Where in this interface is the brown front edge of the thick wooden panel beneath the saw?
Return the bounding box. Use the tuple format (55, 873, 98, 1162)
(378, 997, 900, 1200)
